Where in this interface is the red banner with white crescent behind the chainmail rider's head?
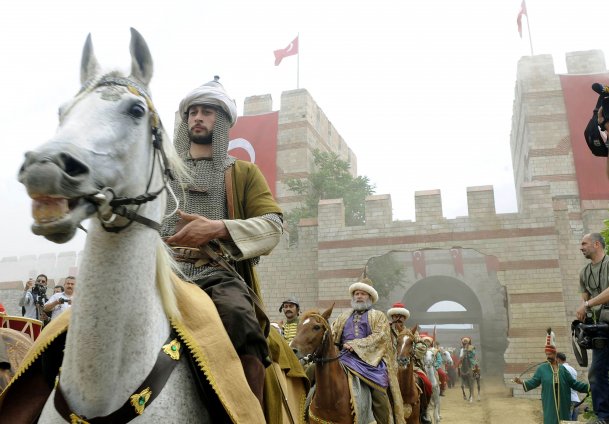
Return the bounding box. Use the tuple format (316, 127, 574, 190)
(228, 112, 279, 196)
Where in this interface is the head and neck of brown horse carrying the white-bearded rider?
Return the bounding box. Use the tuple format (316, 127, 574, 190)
(290, 305, 354, 424)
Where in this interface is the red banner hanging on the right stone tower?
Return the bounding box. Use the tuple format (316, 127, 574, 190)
(560, 73, 609, 200)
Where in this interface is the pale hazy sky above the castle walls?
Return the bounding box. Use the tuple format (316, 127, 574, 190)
(0, 0, 609, 257)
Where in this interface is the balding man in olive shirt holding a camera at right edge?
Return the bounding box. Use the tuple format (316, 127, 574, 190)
(575, 233, 609, 424)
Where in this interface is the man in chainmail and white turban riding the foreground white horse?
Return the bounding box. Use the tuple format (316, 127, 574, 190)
(161, 77, 283, 402)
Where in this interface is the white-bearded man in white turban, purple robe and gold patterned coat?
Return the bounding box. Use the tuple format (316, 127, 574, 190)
(332, 278, 404, 424)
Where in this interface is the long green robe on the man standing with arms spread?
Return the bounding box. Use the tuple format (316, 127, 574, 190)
(522, 362, 590, 424)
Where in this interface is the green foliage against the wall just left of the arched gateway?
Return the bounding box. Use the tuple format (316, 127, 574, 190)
(366, 252, 406, 310)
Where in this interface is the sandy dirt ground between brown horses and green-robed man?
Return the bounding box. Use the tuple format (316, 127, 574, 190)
(432, 377, 543, 424)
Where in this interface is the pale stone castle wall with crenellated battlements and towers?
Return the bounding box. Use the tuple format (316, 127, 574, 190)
(0, 51, 609, 396)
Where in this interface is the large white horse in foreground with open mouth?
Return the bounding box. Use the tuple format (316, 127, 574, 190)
(8, 29, 264, 423)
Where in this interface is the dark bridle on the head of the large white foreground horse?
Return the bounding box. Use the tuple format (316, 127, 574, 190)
(71, 75, 174, 233)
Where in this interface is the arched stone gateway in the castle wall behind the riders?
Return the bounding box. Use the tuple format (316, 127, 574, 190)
(368, 248, 508, 374)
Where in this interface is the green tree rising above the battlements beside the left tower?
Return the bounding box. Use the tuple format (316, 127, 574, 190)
(285, 150, 374, 242)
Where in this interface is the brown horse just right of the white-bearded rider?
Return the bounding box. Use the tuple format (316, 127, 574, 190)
(397, 325, 427, 424)
